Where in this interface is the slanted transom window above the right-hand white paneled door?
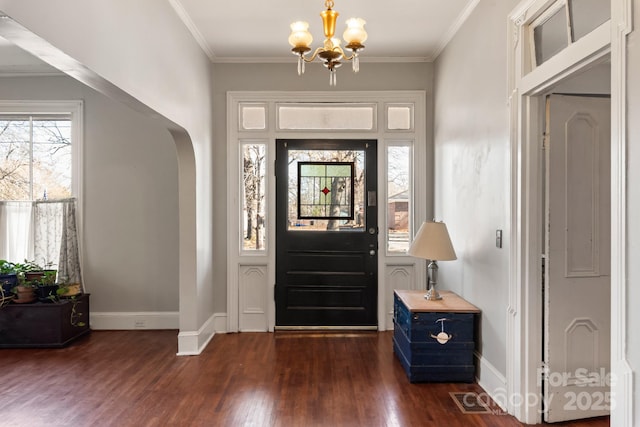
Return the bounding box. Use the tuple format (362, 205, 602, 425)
(529, 0, 611, 67)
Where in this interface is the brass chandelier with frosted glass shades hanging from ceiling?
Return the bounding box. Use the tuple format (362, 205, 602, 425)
(289, 0, 367, 86)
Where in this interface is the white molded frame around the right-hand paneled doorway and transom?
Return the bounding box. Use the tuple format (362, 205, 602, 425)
(506, 0, 633, 426)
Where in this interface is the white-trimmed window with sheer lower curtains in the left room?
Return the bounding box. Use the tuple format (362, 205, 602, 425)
(0, 101, 83, 266)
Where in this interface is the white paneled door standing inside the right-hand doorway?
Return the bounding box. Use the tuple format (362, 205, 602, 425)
(543, 95, 613, 422)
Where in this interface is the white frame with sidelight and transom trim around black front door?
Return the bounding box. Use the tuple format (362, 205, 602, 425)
(226, 90, 433, 332)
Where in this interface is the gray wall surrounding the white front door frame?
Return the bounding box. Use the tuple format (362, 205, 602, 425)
(212, 61, 433, 312)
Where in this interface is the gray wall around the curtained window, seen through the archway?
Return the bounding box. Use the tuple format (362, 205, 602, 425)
(0, 76, 178, 312)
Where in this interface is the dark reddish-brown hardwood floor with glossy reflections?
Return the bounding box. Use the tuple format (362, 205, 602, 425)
(0, 331, 609, 427)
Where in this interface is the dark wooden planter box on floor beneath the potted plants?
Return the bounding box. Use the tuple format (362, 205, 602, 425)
(0, 294, 90, 348)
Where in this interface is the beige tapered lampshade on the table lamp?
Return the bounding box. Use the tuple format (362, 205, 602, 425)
(407, 221, 457, 261)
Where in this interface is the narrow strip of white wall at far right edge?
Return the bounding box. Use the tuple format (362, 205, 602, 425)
(626, 2, 640, 425)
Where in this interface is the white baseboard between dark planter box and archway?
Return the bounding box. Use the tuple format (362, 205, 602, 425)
(89, 311, 180, 330)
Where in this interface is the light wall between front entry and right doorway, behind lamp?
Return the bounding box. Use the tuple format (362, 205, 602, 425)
(434, 0, 514, 386)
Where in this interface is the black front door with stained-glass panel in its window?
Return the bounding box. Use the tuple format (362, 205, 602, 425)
(275, 140, 378, 329)
